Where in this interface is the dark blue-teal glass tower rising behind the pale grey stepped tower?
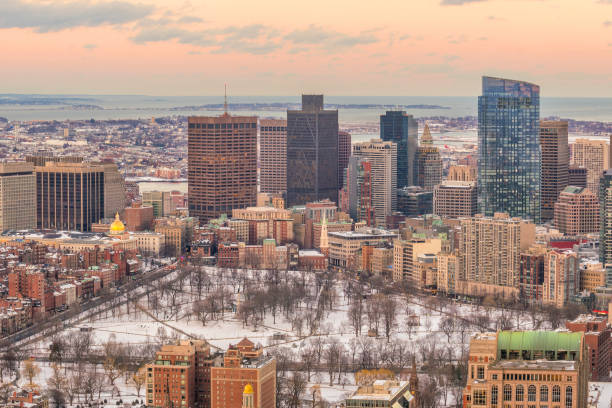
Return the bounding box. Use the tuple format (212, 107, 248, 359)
(380, 111, 419, 188)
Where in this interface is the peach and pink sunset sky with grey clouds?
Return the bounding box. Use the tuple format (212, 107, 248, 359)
(0, 0, 612, 97)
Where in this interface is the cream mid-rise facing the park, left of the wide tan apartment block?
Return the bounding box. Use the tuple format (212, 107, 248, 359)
(393, 237, 442, 290)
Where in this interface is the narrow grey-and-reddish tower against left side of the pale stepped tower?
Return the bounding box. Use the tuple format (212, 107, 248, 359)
(342, 156, 375, 226)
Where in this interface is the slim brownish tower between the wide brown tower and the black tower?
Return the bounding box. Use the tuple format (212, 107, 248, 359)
(259, 119, 287, 194)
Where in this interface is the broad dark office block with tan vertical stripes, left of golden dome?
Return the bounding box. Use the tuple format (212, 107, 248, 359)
(34, 161, 104, 231)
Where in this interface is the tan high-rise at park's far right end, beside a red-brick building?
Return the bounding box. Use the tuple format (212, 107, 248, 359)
(542, 250, 580, 308)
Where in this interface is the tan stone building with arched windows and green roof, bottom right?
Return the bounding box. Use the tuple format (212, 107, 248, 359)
(463, 331, 589, 408)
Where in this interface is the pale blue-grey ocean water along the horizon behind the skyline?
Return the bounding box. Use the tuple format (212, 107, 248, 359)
(0, 94, 612, 125)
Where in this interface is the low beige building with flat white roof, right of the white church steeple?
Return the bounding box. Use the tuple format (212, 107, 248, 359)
(328, 230, 397, 271)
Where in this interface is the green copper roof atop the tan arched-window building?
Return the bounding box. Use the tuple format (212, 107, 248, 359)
(497, 331, 582, 352)
